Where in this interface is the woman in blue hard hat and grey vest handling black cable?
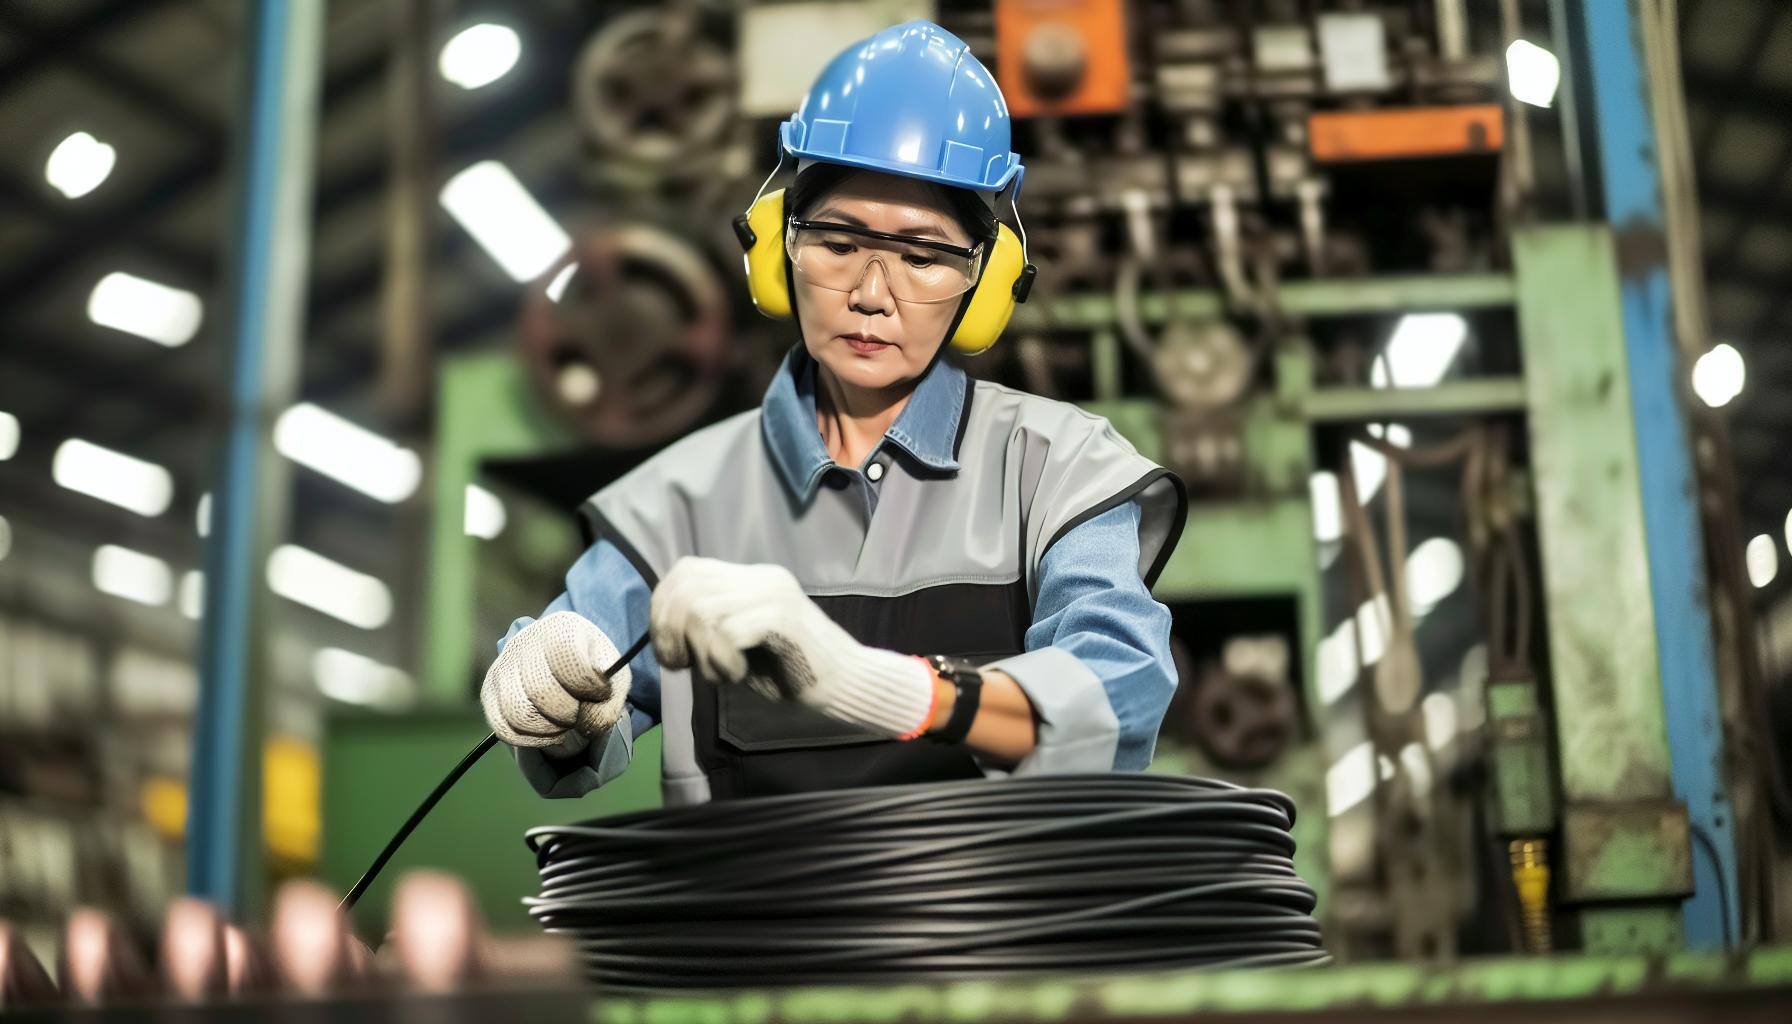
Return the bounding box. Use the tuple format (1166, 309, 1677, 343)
(480, 22, 1186, 805)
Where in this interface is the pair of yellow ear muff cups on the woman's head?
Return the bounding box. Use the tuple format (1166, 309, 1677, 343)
(735, 188, 1034, 355)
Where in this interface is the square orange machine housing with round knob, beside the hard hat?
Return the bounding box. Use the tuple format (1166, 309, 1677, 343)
(996, 0, 1133, 117)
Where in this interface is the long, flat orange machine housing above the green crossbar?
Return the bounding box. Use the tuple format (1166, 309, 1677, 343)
(1306, 104, 1505, 163)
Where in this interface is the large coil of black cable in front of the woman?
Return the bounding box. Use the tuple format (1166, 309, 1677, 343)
(523, 773, 1328, 990)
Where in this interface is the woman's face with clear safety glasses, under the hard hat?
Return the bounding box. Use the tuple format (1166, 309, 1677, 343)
(794, 172, 971, 391)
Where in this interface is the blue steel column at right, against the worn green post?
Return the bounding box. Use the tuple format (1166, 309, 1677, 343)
(1575, 0, 1740, 949)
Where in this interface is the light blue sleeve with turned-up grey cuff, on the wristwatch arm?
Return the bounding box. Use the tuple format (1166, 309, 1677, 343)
(987, 502, 1176, 775)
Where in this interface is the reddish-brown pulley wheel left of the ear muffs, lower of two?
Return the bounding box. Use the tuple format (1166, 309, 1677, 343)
(520, 224, 729, 448)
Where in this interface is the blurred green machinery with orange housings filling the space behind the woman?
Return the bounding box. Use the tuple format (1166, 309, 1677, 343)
(10, 0, 1792, 1024)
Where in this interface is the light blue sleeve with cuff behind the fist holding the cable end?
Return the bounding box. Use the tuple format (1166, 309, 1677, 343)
(498, 540, 659, 798)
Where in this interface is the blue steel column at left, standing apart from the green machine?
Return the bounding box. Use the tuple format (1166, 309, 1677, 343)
(186, 0, 324, 913)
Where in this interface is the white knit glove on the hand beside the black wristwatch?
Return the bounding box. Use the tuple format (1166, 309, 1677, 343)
(650, 558, 934, 739)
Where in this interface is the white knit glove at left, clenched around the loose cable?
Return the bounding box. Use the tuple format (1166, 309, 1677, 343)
(478, 612, 629, 753)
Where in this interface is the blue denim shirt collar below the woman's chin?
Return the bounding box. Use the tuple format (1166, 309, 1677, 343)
(760, 344, 969, 506)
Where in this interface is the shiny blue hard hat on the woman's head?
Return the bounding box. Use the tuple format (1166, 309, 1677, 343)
(778, 22, 1025, 194)
